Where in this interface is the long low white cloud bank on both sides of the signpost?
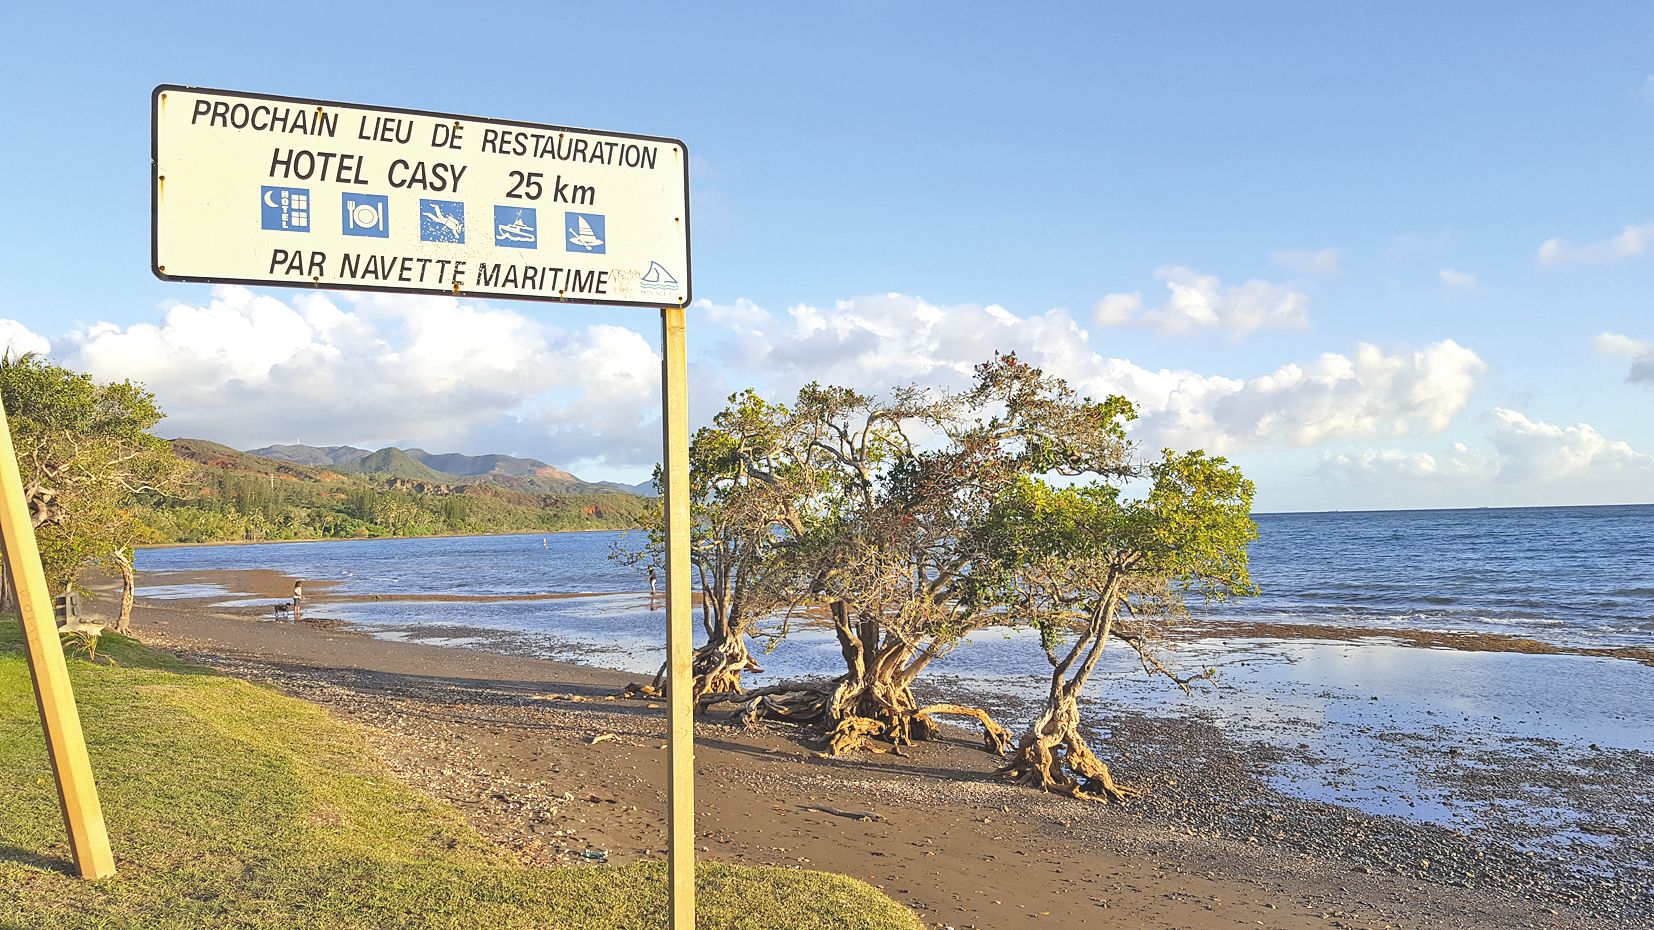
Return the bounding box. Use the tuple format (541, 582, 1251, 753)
(25, 286, 1485, 473)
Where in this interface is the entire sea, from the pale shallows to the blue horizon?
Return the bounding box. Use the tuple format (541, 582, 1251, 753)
(137, 505, 1654, 867)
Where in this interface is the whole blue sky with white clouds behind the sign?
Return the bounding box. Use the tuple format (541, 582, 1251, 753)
(0, 2, 1654, 511)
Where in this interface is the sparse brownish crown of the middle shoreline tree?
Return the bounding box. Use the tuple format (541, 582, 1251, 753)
(792, 354, 1136, 648)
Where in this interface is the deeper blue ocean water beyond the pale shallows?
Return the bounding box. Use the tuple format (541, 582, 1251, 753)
(137, 505, 1654, 645)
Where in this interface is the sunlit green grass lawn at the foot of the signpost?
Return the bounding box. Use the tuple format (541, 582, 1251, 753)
(0, 617, 921, 930)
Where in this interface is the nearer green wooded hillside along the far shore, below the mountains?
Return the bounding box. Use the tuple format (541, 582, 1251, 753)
(139, 439, 652, 543)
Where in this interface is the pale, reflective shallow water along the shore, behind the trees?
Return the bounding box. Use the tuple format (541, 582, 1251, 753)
(294, 594, 1654, 846)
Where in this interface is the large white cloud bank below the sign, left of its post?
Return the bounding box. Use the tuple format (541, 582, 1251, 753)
(56, 286, 678, 468)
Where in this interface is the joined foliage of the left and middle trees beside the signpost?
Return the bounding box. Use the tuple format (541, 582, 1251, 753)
(655, 354, 1171, 713)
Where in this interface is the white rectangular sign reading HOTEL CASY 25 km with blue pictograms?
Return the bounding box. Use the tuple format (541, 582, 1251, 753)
(152, 84, 690, 306)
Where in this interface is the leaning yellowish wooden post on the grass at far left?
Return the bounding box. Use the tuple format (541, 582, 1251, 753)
(0, 393, 114, 879)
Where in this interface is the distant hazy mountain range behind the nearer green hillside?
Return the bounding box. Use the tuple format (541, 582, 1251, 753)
(246, 443, 655, 496)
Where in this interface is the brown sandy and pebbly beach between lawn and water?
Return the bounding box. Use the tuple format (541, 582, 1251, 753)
(74, 571, 1654, 930)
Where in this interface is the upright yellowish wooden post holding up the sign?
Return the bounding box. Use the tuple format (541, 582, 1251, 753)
(660, 306, 695, 930)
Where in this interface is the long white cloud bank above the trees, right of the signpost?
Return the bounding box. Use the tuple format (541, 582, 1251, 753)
(696, 295, 1485, 452)
